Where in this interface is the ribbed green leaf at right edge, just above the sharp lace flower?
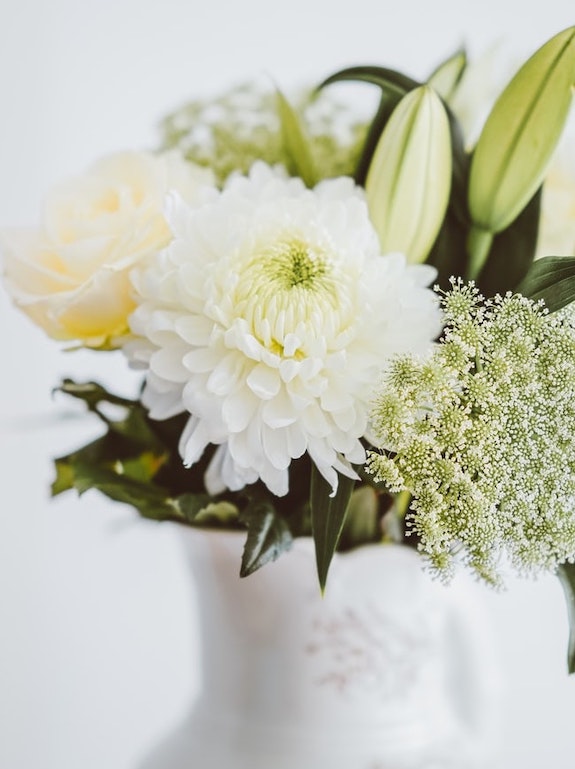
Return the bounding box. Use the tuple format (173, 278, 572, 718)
(517, 256, 575, 312)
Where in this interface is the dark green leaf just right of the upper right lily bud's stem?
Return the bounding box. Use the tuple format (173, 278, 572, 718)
(477, 189, 541, 296)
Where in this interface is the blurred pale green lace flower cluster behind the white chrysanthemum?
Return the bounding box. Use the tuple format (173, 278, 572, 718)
(160, 83, 367, 183)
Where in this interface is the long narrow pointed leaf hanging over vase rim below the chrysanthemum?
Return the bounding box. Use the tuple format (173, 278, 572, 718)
(310, 465, 355, 593)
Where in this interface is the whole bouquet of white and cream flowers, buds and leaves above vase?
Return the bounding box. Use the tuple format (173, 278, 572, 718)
(2, 28, 575, 672)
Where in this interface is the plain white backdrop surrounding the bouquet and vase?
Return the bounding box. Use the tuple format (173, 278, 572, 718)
(0, 0, 575, 769)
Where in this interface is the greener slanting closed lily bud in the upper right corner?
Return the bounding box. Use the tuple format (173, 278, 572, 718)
(469, 27, 575, 237)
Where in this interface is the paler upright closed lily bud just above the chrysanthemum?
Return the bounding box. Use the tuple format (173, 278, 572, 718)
(365, 85, 452, 263)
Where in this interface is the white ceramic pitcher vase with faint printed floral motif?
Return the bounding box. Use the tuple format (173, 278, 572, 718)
(141, 530, 497, 769)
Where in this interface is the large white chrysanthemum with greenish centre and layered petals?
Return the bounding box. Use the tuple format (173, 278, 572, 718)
(127, 163, 440, 496)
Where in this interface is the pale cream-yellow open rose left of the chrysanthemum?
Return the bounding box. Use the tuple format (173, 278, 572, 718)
(0, 152, 213, 347)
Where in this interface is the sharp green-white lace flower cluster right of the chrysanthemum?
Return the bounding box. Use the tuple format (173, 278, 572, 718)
(368, 282, 575, 584)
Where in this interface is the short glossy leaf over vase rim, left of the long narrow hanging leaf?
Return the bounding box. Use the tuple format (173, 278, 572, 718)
(240, 498, 293, 577)
